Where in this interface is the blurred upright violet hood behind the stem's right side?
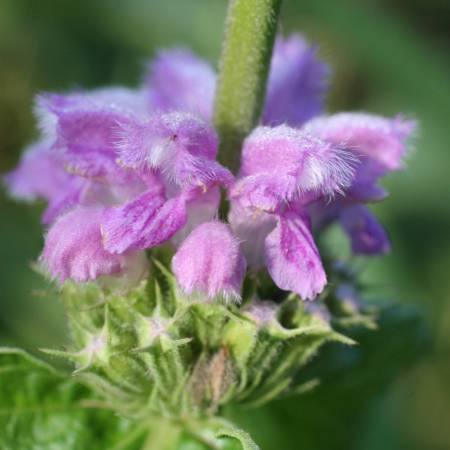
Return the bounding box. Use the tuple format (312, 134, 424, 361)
(263, 34, 329, 126)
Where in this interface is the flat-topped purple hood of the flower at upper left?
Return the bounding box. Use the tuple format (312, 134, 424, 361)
(36, 88, 144, 182)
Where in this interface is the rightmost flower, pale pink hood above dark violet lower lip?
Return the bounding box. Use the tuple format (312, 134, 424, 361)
(303, 113, 415, 255)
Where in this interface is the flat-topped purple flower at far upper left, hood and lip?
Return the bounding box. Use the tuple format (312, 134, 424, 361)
(22, 88, 156, 224)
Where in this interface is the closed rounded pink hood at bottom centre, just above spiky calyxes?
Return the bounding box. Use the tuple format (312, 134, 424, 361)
(172, 222, 246, 301)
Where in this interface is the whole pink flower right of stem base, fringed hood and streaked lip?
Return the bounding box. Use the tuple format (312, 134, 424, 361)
(229, 125, 355, 299)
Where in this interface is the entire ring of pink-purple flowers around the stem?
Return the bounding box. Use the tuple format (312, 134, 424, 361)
(6, 35, 414, 300)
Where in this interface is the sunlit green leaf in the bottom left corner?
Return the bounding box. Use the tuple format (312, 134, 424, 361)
(0, 348, 144, 450)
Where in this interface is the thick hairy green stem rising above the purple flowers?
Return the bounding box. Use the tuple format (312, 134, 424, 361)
(215, 0, 281, 171)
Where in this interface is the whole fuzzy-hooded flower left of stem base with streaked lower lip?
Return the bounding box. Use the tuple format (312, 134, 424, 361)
(102, 113, 233, 253)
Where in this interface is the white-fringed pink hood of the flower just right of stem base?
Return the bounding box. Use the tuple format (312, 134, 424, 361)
(231, 125, 356, 212)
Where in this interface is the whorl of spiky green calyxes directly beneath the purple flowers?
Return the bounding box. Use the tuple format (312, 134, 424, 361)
(47, 261, 351, 418)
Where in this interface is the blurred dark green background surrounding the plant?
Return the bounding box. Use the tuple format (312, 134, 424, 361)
(0, 0, 450, 450)
